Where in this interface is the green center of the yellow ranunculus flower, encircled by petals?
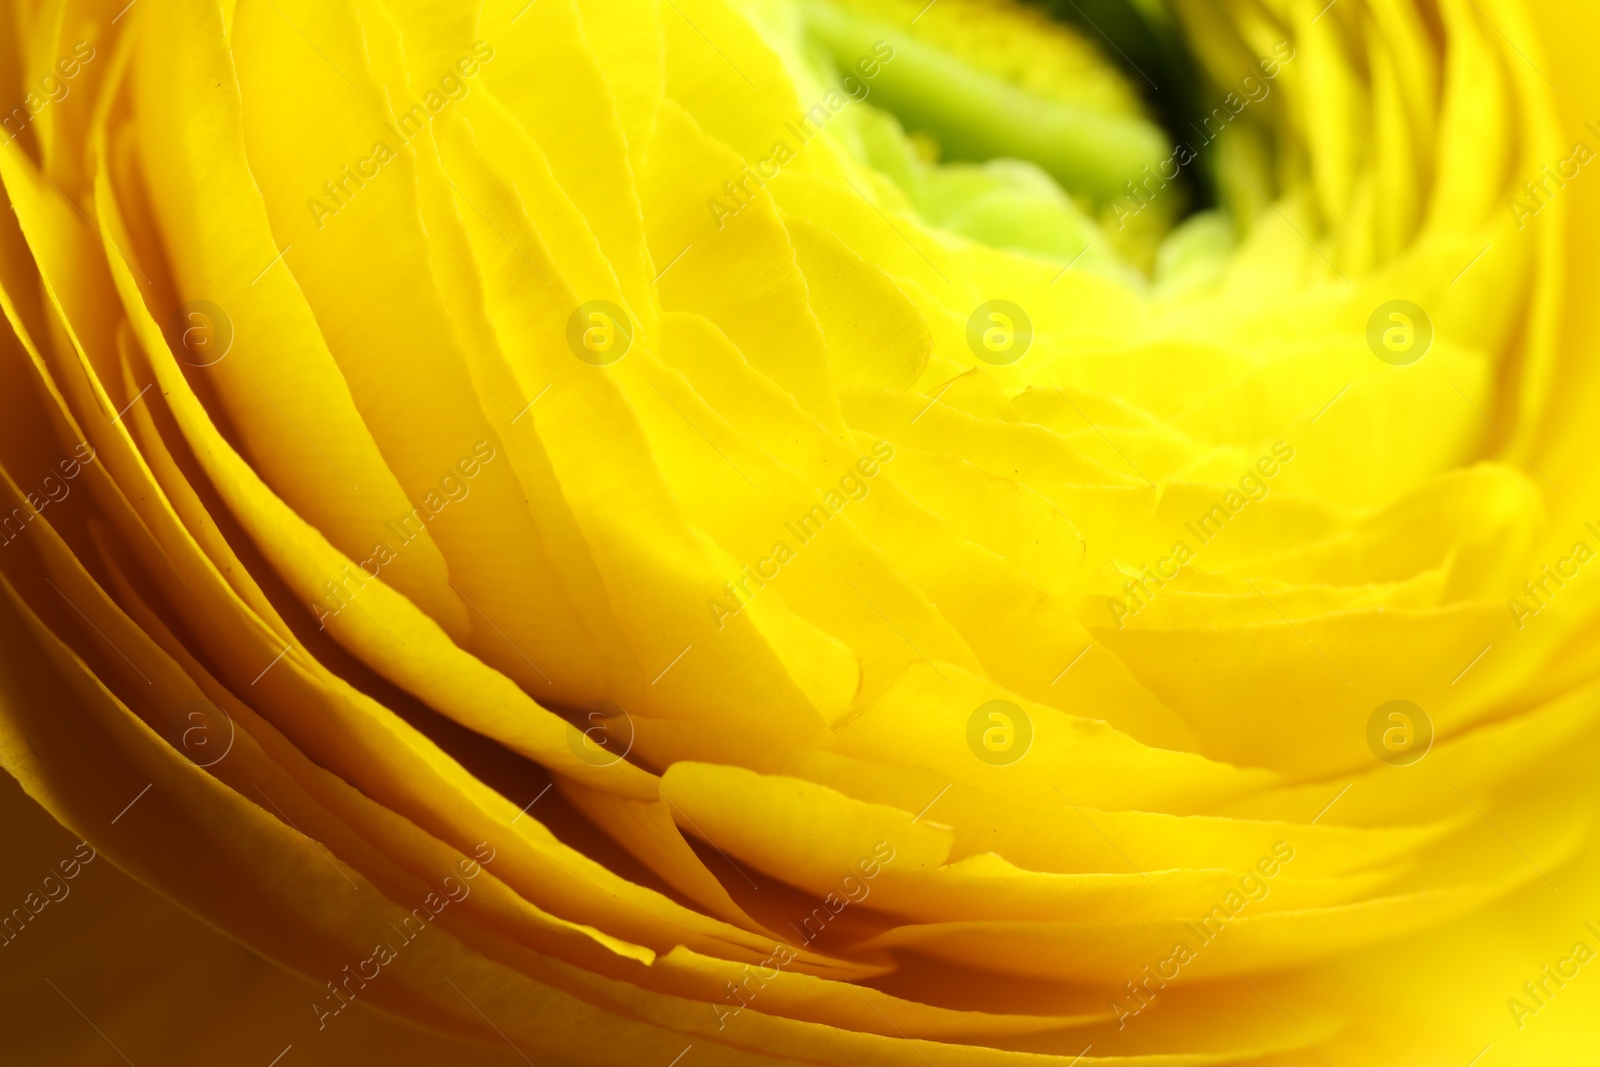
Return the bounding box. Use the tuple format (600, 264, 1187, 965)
(800, 0, 1222, 278)
